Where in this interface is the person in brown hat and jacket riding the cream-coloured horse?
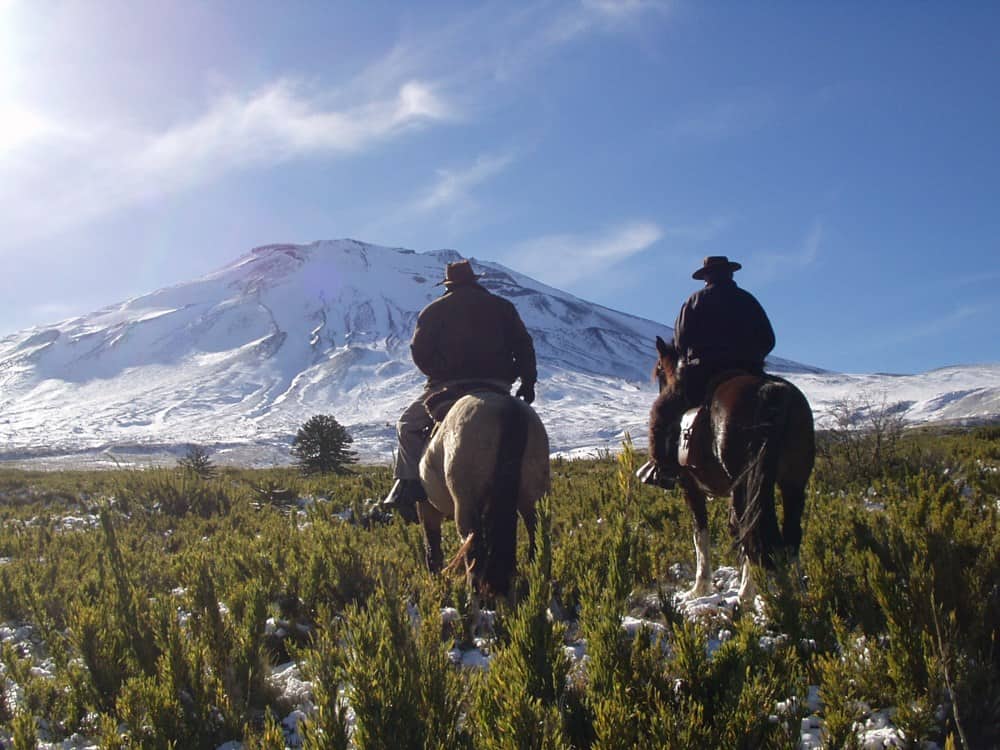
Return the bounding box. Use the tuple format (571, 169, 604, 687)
(381, 260, 538, 523)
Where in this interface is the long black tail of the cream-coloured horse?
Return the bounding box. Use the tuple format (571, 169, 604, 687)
(468, 398, 529, 596)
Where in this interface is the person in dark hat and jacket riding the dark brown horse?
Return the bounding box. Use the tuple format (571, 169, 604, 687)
(649, 255, 774, 487)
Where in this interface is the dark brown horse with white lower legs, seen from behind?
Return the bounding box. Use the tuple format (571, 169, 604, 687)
(639, 336, 816, 600)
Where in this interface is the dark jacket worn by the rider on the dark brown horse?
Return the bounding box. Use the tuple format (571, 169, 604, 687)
(674, 279, 774, 369)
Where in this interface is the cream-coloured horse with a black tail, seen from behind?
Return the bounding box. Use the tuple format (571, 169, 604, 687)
(417, 392, 549, 596)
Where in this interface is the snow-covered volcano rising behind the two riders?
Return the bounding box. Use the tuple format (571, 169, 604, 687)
(0, 240, 1000, 470)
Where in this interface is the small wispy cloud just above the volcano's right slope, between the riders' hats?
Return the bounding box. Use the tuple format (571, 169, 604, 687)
(504, 221, 664, 286)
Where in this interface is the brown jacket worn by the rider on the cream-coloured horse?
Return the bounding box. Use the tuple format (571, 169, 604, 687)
(410, 284, 538, 394)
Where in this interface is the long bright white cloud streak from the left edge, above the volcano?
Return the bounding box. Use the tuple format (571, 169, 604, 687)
(0, 80, 452, 240)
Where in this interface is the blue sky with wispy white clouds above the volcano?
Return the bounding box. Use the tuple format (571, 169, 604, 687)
(0, 0, 1000, 372)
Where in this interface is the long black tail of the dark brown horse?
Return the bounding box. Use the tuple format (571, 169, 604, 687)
(735, 381, 791, 568)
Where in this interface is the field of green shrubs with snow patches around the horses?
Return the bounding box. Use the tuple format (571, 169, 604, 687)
(0, 428, 1000, 748)
